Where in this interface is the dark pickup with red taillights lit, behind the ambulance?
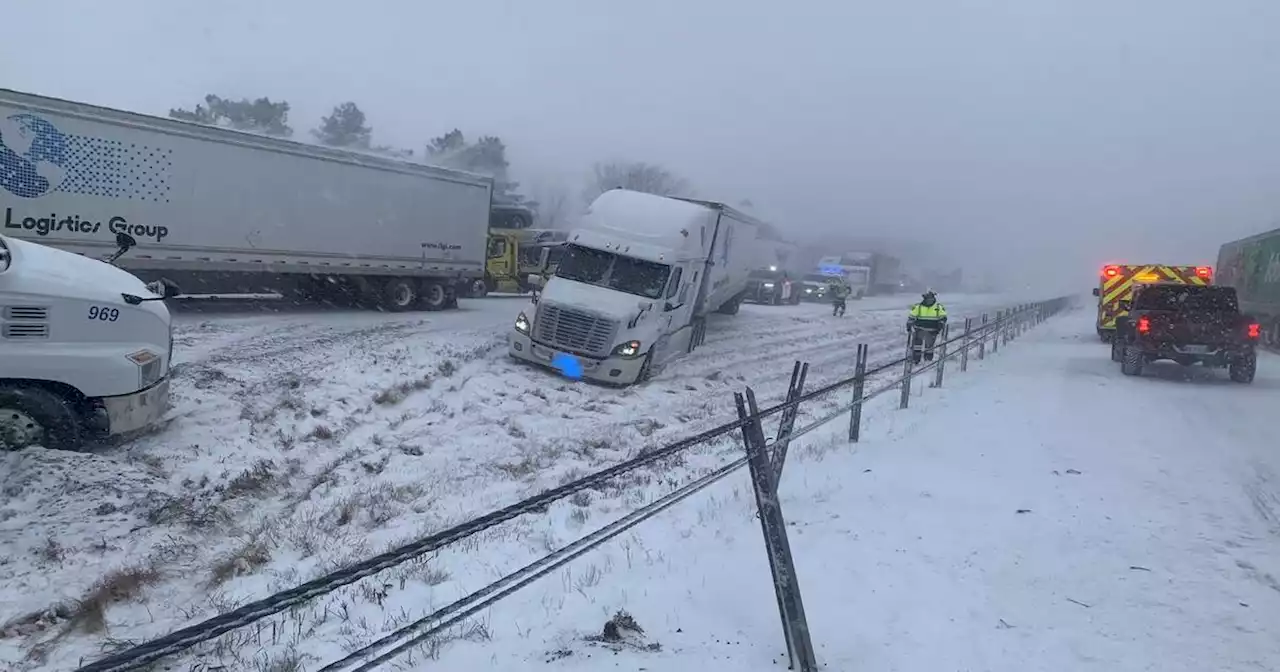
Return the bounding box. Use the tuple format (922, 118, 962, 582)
(1111, 283, 1262, 383)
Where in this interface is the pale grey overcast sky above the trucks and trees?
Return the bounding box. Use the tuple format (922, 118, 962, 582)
(0, 0, 1280, 287)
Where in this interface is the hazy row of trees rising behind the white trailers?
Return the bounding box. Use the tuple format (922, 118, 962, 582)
(169, 93, 727, 220)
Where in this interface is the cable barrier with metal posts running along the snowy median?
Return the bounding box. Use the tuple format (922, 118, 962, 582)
(77, 297, 1073, 672)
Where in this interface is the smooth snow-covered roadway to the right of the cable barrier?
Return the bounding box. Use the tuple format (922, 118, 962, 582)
(422, 302, 1280, 672)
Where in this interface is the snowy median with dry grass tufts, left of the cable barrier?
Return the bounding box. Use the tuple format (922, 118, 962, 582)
(0, 296, 1009, 669)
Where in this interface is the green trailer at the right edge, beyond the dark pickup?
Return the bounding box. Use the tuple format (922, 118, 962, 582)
(1217, 229, 1280, 348)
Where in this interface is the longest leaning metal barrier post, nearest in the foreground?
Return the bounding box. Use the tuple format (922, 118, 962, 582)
(733, 388, 818, 672)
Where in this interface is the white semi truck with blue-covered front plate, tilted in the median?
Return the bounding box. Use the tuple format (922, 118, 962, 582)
(508, 189, 760, 385)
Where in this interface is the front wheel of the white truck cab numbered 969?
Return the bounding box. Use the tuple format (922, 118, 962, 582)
(0, 387, 83, 452)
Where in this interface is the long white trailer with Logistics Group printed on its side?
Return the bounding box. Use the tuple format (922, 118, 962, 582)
(0, 90, 493, 311)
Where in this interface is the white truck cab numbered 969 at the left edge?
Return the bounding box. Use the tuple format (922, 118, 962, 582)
(0, 236, 178, 451)
